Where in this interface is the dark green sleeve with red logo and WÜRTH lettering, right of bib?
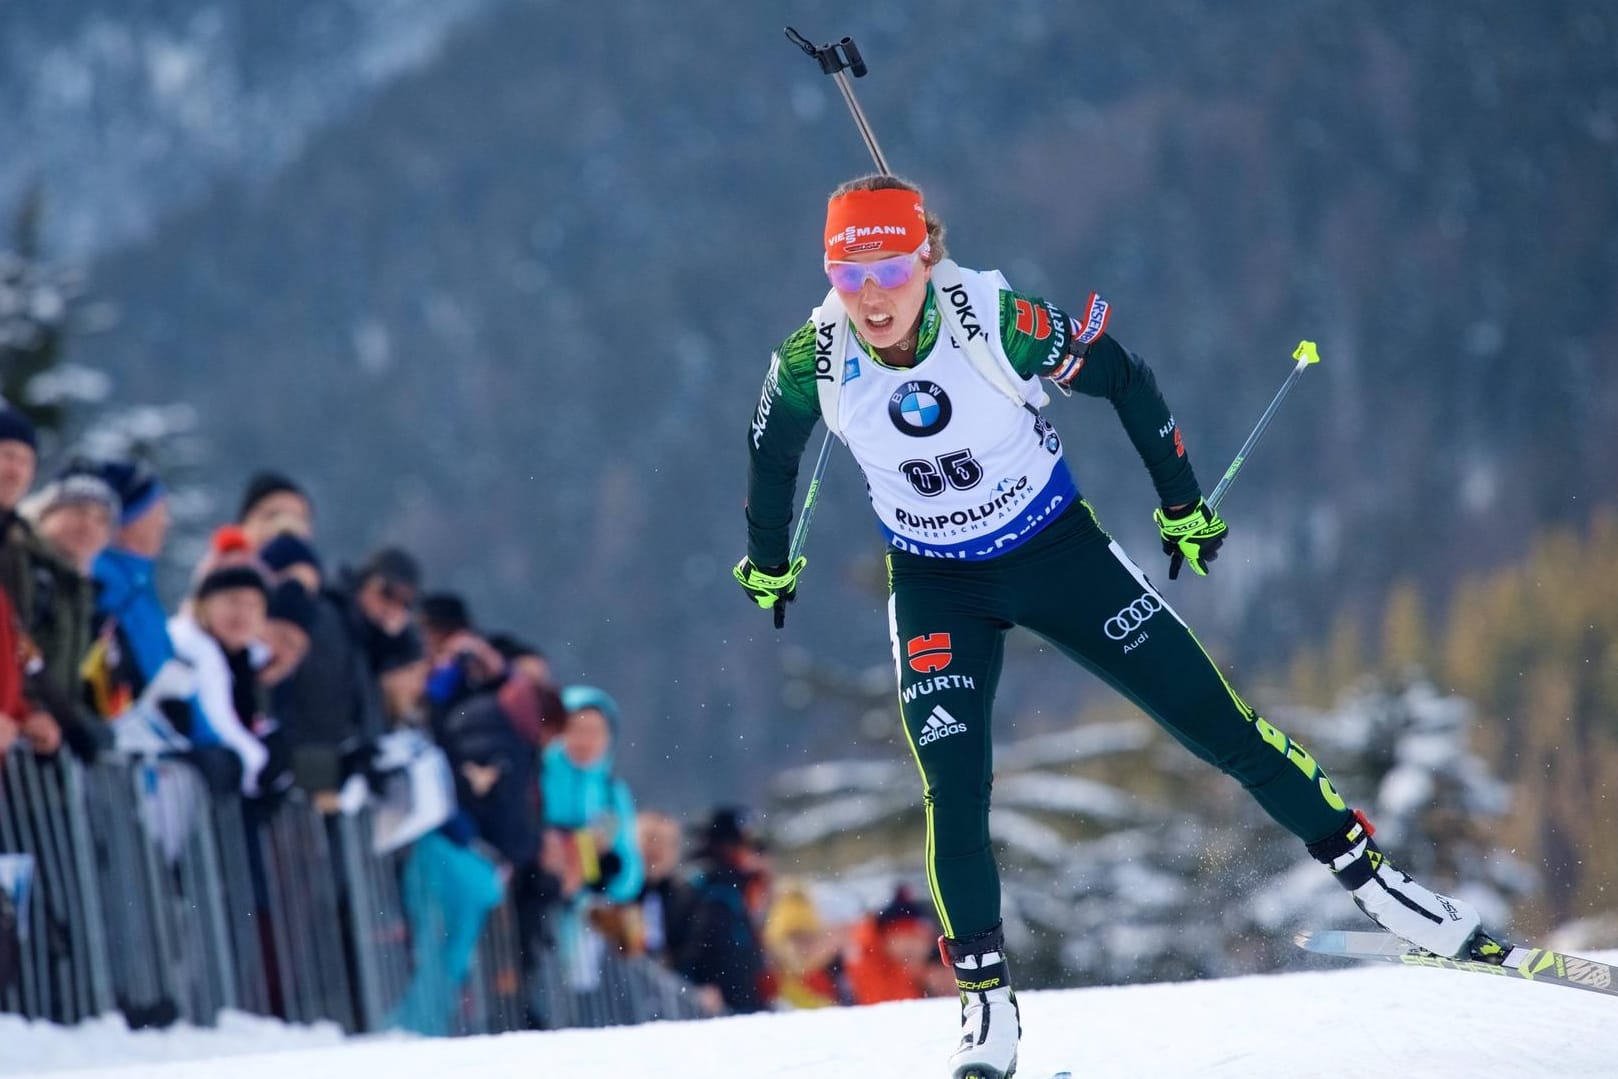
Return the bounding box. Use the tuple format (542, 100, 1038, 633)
(1000, 291, 1201, 506)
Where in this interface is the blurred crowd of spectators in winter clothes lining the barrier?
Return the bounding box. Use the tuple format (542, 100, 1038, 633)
(0, 406, 955, 1034)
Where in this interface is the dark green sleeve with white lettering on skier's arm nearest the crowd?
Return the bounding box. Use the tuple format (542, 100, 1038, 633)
(748, 322, 820, 566)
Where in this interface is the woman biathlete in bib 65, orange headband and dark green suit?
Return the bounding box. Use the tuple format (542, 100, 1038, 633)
(735, 176, 1497, 1079)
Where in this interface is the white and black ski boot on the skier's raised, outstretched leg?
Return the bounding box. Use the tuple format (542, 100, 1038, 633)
(1309, 809, 1482, 963)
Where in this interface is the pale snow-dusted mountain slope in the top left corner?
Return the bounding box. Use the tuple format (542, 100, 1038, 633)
(0, 0, 492, 256)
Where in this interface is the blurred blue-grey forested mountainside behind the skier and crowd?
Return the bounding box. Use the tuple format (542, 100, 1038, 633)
(0, 0, 1618, 975)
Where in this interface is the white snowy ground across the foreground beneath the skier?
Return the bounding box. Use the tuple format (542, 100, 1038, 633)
(0, 967, 1618, 1079)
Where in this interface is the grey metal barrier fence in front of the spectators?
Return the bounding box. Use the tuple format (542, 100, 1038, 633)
(0, 746, 704, 1034)
